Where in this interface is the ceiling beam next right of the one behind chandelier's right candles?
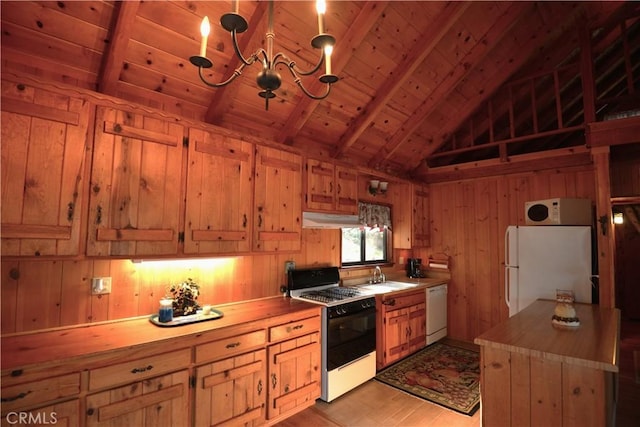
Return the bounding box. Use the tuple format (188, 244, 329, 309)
(334, 2, 471, 158)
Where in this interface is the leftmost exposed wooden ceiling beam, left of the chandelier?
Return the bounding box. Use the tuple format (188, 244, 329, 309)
(97, 0, 140, 95)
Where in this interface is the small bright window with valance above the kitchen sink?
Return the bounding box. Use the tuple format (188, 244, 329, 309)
(342, 227, 390, 266)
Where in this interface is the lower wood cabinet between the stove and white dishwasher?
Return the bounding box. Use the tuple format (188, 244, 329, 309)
(376, 289, 427, 370)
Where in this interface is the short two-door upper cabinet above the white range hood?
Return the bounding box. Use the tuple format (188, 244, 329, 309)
(305, 159, 358, 214)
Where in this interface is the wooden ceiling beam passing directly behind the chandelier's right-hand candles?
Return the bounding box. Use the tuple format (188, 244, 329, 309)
(277, 1, 388, 145)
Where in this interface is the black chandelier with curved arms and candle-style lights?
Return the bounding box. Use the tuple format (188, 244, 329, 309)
(189, 0, 338, 110)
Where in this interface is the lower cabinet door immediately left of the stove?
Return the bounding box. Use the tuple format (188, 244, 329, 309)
(267, 332, 320, 420)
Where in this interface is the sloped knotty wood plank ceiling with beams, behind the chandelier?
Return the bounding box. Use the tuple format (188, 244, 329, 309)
(1, 0, 640, 176)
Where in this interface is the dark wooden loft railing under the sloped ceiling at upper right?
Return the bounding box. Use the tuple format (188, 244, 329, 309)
(427, 10, 640, 168)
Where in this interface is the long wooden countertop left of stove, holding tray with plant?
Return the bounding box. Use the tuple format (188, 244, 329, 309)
(1, 296, 320, 372)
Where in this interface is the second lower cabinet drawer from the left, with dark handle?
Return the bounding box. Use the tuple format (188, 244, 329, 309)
(89, 348, 191, 390)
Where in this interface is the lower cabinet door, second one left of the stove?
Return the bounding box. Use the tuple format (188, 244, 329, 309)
(194, 350, 267, 426)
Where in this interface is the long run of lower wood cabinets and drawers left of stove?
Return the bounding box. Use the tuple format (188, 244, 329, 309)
(0, 302, 321, 427)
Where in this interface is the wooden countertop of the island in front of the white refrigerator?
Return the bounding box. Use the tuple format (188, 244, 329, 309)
(474, 300, 620, 372)
